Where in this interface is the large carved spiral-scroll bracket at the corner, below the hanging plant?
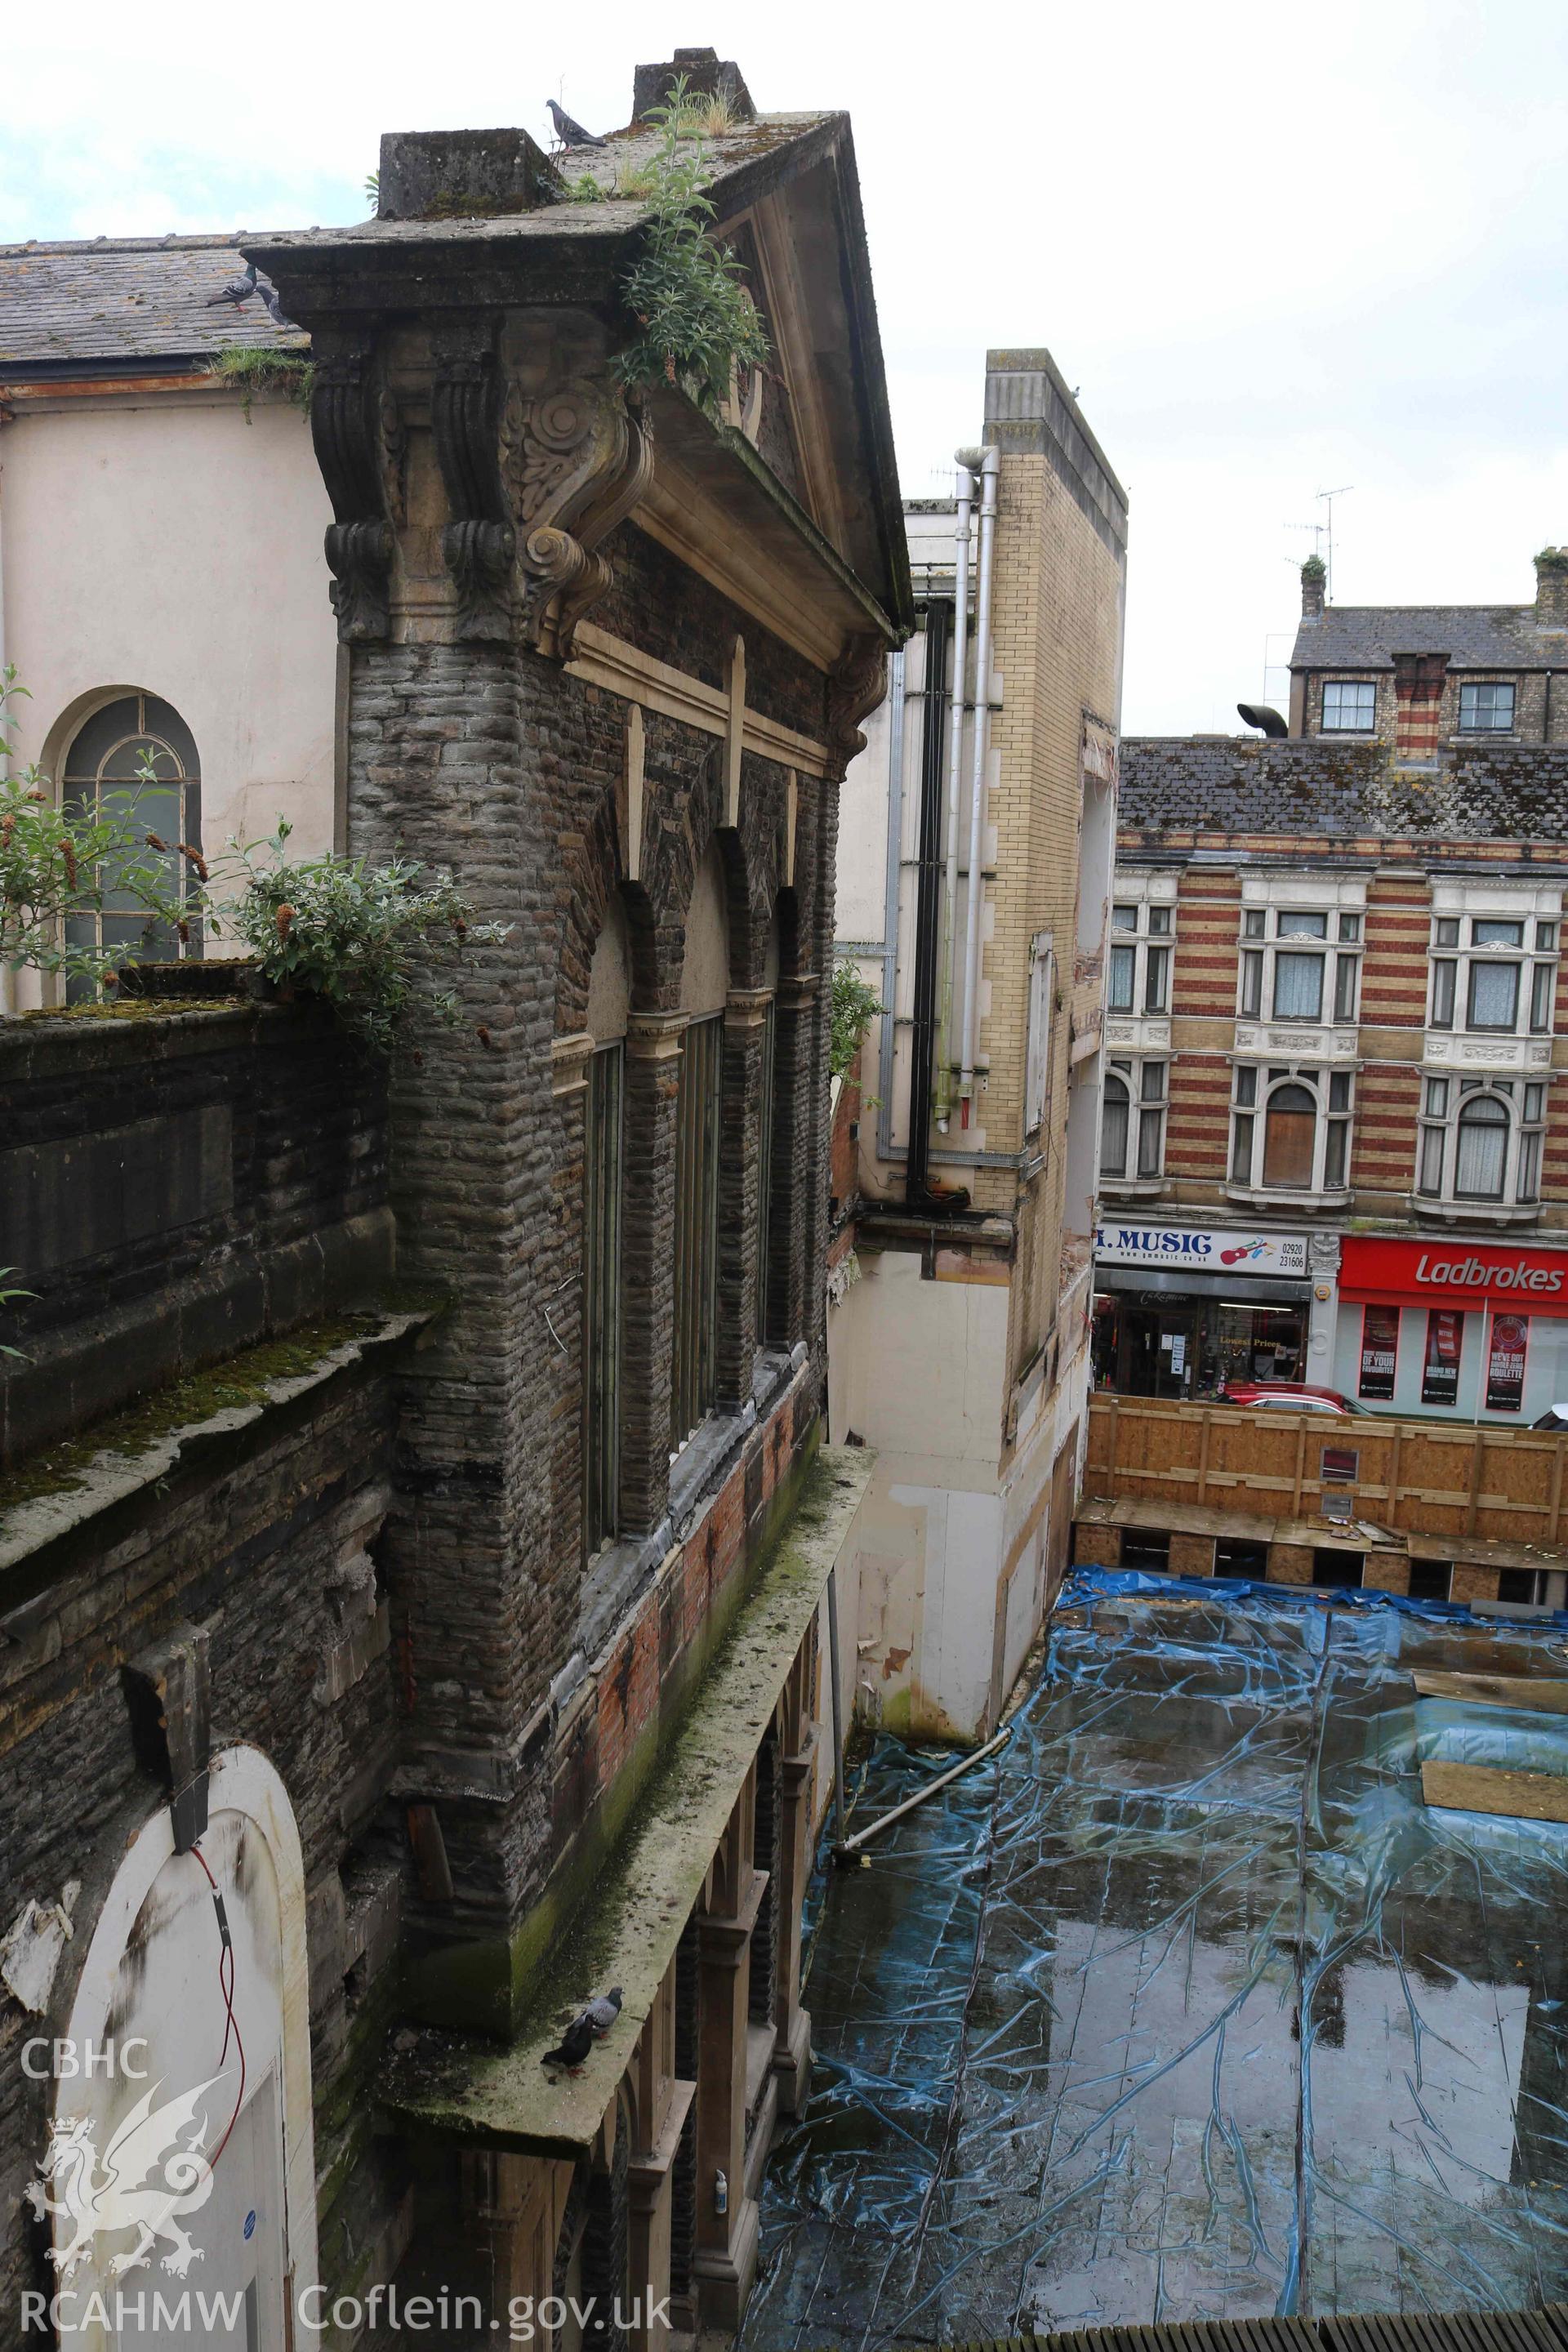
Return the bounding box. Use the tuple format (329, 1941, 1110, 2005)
(501, 376, 653, 661)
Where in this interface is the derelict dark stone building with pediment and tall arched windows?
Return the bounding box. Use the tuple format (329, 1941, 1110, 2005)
(0, 56, 907, 2347)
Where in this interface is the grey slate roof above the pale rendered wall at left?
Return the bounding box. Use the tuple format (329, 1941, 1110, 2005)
(0, 235, 310, 381)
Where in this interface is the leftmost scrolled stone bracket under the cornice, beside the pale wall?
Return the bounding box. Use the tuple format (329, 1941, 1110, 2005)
(310, 345, 402, 644)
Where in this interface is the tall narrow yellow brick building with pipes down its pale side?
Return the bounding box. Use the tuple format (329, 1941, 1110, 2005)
(830, 350, 1126, 1738)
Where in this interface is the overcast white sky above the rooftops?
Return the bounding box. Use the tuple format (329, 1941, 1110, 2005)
(0, 0, 1568, 734)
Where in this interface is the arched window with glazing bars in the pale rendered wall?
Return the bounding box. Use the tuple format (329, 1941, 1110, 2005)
(61, 694, 203, 995)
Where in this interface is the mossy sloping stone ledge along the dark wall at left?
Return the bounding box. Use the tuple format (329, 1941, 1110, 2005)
(0, 1294, 439, 1519)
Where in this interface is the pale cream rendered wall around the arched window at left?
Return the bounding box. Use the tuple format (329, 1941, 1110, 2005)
(0, 393, 336, 889)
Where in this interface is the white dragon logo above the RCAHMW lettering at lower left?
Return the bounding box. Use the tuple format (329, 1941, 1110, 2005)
(26, 2074, 223, 2279)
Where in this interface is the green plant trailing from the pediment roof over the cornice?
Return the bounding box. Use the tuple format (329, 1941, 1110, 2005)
(613, 75, 768, 412)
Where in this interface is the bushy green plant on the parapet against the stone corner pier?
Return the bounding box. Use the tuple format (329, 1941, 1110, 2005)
(212, 818, 513, 1056)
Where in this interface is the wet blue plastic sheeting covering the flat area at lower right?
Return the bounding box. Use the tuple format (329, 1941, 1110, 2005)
(741, 1571, 1568, 2352)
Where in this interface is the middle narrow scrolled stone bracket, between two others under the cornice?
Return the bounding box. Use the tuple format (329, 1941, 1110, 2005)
(430, 323, 517, 639)
